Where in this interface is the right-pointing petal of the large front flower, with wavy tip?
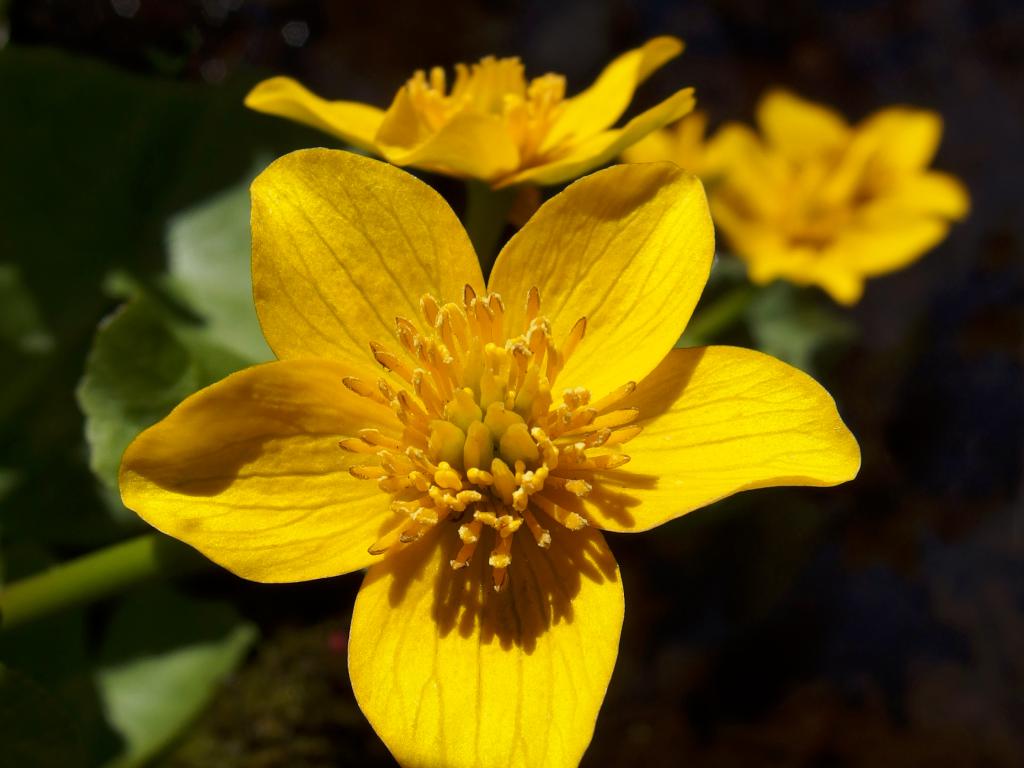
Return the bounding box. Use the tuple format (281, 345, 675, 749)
(584, 346, 860, 530)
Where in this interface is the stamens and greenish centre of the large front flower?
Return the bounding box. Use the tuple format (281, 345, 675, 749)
(340, 286, 640, 590)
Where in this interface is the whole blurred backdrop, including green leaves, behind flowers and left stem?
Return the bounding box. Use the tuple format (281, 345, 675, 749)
(0, 0, 1024, 768)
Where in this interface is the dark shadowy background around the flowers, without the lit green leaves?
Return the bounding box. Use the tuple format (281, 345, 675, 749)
(0, 0, 1024, 768)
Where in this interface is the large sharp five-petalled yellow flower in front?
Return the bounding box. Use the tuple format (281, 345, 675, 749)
(121, 150, 860, 768)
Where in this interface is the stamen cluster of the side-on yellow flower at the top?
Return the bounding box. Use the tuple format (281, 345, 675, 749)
(406, 56, 565, 166)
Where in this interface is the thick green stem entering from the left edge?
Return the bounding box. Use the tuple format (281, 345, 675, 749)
(0, 534, 208, 631)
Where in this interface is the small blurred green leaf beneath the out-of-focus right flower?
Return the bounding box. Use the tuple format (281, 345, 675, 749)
(746, 281, 857, 374)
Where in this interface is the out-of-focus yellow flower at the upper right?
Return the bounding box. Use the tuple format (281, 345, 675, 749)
(711, 90, 969, 304)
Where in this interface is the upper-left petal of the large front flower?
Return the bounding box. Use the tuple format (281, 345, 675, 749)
(252, 150, 483, 365)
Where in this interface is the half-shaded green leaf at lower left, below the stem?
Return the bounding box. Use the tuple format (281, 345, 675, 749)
(96, 589, 257, 768)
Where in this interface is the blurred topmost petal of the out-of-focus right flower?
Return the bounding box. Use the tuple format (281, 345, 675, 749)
(757, 90, 850, 160)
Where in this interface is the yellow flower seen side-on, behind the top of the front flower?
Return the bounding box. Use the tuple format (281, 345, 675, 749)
(246, 37, 693, 187)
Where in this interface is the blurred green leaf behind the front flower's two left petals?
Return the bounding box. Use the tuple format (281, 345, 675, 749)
(78, 171, 272, 487)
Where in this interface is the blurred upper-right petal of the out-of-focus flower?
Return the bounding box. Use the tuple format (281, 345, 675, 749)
(858, 106, 942, 171)
